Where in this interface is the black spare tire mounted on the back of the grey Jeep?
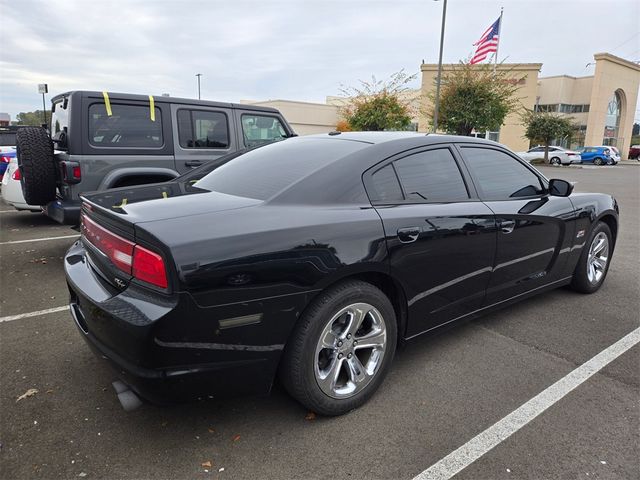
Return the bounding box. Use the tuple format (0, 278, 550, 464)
(16, 127, 56, 205)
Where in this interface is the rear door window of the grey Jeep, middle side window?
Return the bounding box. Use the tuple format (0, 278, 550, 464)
(178, 109, 229, 148)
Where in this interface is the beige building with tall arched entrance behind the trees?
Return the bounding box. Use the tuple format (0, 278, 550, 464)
(243, 53, 640, 158)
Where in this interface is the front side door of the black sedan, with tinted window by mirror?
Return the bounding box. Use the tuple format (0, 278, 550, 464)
(459, 144, 575, 305)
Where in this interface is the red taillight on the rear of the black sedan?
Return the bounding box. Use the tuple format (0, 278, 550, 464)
(81, 213, 168, 288)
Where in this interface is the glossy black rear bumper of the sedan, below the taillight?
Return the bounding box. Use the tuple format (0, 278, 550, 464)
(64, 241, 298, 404)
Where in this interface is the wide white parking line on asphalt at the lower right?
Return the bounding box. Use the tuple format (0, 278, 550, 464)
(413, 328, 640, 480)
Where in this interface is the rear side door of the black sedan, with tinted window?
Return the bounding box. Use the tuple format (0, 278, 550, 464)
(365, 145, 496, 337)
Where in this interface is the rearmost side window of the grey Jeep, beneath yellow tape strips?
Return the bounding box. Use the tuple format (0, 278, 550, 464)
(89, 103, 164, 148)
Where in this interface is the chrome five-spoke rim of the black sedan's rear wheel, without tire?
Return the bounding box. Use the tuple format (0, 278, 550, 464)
(314, 303, 387, 399)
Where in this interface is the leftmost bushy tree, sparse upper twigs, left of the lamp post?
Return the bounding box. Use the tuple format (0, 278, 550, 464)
(341, 70, 416, 131)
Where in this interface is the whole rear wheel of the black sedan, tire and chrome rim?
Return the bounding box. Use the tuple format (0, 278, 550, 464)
(280, 280, 397, 415)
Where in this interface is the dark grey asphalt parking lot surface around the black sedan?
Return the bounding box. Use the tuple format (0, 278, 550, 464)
(0, 165, 640, 479)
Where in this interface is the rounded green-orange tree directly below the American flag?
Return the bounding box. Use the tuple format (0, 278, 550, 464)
(426, 62, 522, 136)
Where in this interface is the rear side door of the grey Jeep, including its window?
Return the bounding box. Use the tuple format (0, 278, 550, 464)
(171, 104, 238, 174)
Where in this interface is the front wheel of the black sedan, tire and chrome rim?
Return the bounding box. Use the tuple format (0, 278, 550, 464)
(571, 222, 613, 293)
